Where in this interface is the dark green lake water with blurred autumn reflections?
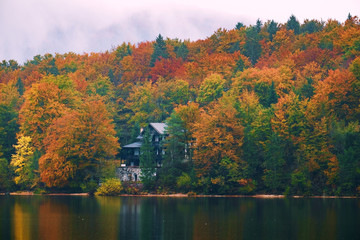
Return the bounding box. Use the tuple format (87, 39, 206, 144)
(0, 196, 360, 240)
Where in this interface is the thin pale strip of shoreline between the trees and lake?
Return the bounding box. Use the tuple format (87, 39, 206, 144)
(0, 191, 359, 199)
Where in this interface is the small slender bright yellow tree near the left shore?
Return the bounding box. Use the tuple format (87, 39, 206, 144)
(11, 135, 36, 189)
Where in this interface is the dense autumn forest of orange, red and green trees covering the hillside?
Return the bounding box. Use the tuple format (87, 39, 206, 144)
(0, 14, 360, 196)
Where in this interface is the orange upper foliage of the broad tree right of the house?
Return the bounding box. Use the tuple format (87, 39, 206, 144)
(193, 98, 244, 177)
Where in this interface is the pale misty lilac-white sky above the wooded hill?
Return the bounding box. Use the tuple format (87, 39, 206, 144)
(0, 0, 360, 64)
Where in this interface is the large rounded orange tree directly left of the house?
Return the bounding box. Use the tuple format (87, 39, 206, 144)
(39, 100, 119, 187)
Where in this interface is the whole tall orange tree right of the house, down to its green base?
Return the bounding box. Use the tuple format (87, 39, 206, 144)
(194, 97, 250, 193)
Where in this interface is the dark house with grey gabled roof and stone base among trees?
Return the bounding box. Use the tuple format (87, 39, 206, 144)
(117, 123, 166, 181)
